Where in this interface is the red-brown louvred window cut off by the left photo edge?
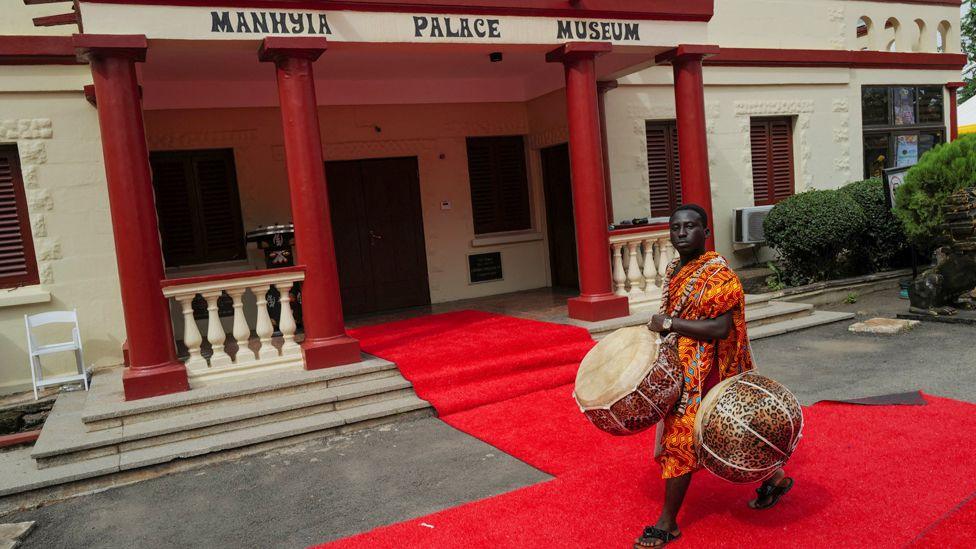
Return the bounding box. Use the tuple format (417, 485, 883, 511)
(0, 145, 39, 288)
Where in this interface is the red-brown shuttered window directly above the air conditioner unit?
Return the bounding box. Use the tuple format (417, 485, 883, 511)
(749, 118, 794, 206)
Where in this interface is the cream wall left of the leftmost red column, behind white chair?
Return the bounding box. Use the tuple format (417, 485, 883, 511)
(0, 67, 125, 393)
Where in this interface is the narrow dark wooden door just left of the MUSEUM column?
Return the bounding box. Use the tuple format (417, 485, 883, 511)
(541, 144, 579, 289)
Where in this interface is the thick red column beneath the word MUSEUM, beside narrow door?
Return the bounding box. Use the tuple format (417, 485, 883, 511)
(546, 46, 630, 322)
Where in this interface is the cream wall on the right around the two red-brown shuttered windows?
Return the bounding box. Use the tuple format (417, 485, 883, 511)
(607, 67, 959, 265)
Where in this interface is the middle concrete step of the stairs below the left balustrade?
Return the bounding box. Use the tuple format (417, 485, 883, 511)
(31, 370, 422, 468)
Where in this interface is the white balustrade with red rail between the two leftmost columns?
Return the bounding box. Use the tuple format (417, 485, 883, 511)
(162, 267, 305, 387)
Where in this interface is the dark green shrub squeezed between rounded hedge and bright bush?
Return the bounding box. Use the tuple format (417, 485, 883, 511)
(839, 178, 908, 273)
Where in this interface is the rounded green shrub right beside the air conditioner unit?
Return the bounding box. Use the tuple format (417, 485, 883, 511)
(763, 190, 867, 285)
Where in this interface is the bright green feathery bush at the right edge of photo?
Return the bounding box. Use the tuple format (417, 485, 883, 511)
(895, 134, 976, 249)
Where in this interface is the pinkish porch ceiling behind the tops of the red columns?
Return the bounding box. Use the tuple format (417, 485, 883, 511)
(140, 40, 665, 110)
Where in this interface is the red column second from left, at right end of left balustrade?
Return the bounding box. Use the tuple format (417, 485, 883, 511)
(258, 37, 360, 370)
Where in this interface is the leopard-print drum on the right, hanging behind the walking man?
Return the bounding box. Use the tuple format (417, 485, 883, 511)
(695, 372, 803, 483)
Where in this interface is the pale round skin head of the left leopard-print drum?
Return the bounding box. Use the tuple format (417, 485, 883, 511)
(574, 326, 657, 409)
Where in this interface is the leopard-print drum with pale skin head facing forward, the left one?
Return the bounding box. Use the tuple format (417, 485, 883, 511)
(573, 326, 681, 435)
